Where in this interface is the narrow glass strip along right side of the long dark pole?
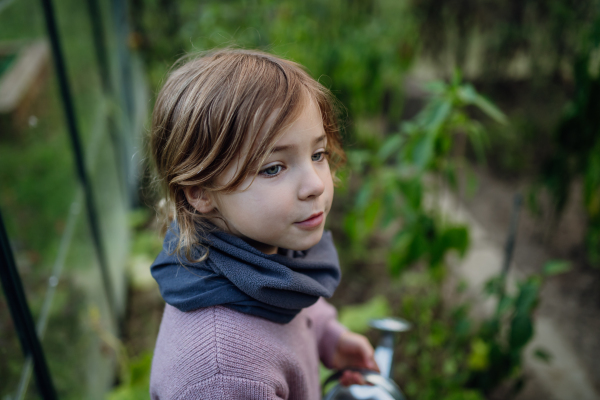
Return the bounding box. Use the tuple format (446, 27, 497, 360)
(55, 0, 129, 312)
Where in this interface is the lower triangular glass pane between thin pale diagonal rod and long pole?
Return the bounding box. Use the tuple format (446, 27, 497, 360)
(42, 209, 116, 399)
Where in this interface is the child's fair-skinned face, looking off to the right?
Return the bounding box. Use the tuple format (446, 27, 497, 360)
(188, 102, 333, 254)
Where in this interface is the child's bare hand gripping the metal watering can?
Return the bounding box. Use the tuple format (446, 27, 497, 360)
(333, 331, 379, 386)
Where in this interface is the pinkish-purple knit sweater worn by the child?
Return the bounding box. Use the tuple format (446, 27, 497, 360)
(150, 299, 345, 400)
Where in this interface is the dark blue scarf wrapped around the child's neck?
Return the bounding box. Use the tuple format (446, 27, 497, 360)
(151, 226, 341, 323)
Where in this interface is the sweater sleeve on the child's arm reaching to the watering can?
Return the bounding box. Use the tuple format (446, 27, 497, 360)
(306, 298, 347, 368)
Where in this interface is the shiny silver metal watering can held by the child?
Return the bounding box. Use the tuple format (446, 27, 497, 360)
(323, 318, 411, 400)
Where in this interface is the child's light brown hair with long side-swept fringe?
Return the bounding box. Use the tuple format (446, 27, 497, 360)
(150, 49, 345, 259)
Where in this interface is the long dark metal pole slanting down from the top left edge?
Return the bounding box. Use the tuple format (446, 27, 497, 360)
(41, 0, 118, 322)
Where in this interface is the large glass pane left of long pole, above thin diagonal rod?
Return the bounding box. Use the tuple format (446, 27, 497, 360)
(0, 0, 78, 332)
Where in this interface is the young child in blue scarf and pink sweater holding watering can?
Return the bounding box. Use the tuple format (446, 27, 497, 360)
(150, 50, 377, 399)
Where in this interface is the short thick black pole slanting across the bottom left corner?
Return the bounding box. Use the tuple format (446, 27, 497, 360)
(0, 213, 57, 400)
